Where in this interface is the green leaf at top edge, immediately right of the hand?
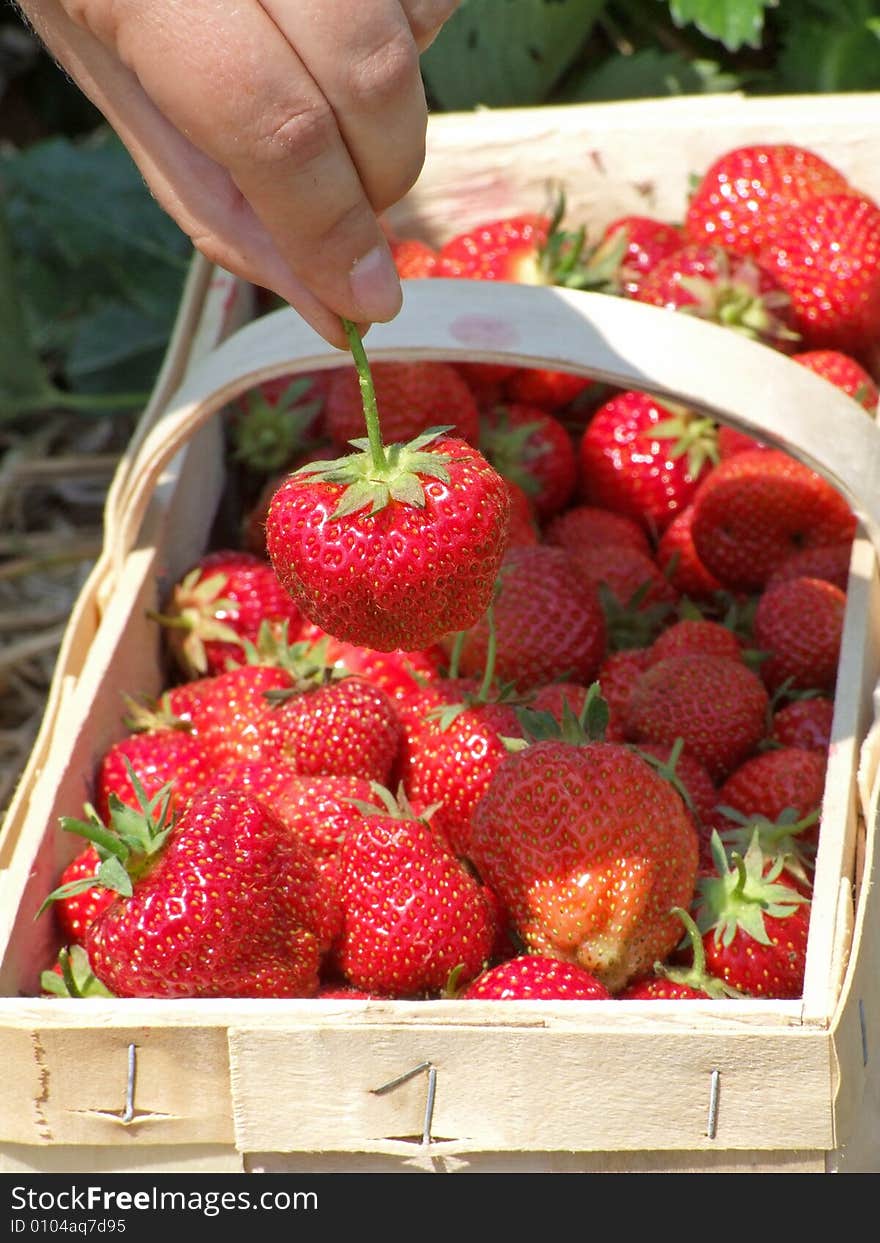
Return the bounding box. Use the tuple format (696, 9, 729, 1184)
(421, 0, 605, 111)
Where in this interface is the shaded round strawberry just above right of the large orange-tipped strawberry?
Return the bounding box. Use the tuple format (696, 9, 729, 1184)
(626, 654, 769, 781)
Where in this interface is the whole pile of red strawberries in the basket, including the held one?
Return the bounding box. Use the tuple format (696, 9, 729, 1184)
(44, 138, 880, 999)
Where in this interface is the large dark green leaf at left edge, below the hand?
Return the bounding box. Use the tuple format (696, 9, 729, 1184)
(0, 128, 191, 410)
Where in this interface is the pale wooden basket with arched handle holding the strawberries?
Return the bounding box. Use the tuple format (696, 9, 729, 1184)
(0, 91, 880, 1172)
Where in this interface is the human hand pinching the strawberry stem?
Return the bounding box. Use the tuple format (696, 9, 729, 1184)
(19, 0, 457, 348)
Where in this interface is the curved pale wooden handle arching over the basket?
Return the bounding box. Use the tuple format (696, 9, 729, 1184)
(108, 280, 880, 558)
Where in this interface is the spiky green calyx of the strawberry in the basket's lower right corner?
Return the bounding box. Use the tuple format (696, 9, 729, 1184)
(697, 830, 808, 946)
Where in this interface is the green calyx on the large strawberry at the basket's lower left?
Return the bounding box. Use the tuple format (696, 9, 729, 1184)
(37, 759, 175, 917)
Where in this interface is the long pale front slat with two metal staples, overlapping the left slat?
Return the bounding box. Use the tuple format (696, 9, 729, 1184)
(230, 1024, 834, 1156)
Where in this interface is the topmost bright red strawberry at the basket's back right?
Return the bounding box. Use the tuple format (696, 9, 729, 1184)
(685, 143, 848, 256)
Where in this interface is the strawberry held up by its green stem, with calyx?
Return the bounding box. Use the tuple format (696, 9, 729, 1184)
(266, 323, 510, 651)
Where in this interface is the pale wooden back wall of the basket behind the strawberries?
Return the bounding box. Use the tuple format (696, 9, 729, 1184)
(389, 94, 880, 245)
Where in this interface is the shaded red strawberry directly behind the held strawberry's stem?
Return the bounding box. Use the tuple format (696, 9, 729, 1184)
(324, 359, 479, 452)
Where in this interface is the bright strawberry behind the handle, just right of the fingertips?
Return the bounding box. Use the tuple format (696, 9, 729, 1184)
(434, 213, 552, 285)
